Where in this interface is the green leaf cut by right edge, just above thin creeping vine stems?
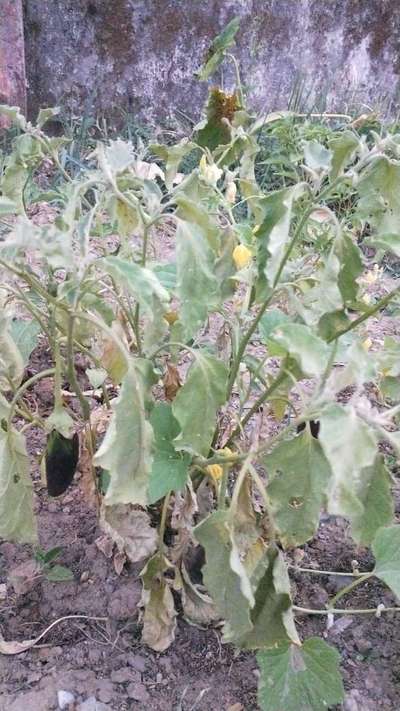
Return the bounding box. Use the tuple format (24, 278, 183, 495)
(372, 526, 400, 599)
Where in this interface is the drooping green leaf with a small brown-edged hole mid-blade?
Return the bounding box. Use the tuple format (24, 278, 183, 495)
(263, 428, 331, 548)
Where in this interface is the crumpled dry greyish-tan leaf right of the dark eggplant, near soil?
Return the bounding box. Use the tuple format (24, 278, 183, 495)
(100, 504, 158, 563)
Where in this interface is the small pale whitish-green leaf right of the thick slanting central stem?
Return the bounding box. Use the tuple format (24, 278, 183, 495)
(271, 323, 329, 376)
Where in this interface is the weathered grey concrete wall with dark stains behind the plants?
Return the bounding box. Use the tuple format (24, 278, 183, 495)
(20, 0, 400, 121)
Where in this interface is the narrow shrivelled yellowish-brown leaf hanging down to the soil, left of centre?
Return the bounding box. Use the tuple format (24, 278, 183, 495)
(140, 553, 176, 652)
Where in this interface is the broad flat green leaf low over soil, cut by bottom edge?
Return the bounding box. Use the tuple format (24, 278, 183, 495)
(257, 637, 344, 711)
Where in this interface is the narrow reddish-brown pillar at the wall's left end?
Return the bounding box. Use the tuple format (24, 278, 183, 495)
(0, 0, 26, 127)
